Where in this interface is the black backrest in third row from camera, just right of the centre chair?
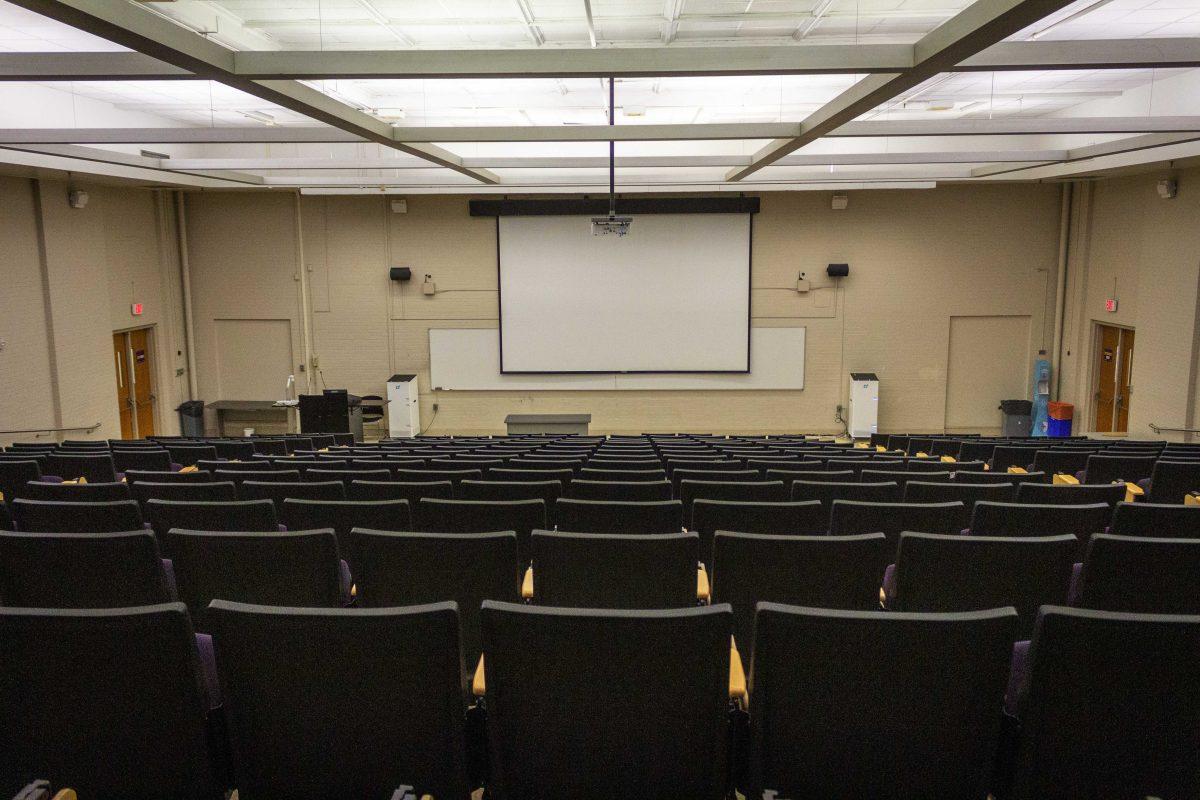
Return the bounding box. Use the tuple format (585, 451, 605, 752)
(691, 500, 829, 567)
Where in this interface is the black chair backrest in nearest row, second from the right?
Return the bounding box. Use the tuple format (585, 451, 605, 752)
(746, 603, 1016, 798)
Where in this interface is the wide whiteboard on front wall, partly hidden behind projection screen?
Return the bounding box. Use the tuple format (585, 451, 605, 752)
(430, 327, 805, 391)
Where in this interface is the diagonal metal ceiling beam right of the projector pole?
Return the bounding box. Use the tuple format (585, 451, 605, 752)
(726, 0, 1070, 181)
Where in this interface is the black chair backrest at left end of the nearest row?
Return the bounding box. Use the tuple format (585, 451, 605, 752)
(0, 603, 224, 800)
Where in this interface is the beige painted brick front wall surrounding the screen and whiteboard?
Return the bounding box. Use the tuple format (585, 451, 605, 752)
(177, 185, 1060, 433)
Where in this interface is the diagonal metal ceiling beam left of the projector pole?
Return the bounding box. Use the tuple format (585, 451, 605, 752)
(0, 0, 499, 184)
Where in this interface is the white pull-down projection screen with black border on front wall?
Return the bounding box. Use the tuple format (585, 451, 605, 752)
(498, 213, 751, 373)
